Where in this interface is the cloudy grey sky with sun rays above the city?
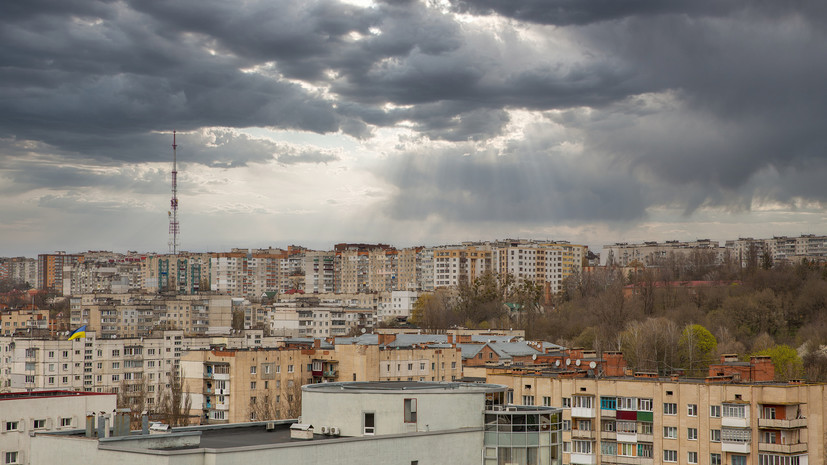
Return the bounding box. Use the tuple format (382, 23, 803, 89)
(0, 0, 827, 256)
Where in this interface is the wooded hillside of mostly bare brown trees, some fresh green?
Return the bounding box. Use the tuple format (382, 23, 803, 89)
(412, 251, 827, 381)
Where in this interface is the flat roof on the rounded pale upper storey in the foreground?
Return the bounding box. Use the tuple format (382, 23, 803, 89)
(302, 381, 508, 394)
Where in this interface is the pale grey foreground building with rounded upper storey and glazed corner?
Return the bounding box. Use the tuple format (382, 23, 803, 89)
(32, 380, 561, 465)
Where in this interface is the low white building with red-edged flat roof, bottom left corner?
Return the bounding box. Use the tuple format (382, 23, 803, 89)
(0, 390, 116, 465)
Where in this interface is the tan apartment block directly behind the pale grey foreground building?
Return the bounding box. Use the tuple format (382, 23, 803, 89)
(181, 338, 462, 424)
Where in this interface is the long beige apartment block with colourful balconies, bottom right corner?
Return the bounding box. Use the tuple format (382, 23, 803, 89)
(487, 368, 827, 465)
